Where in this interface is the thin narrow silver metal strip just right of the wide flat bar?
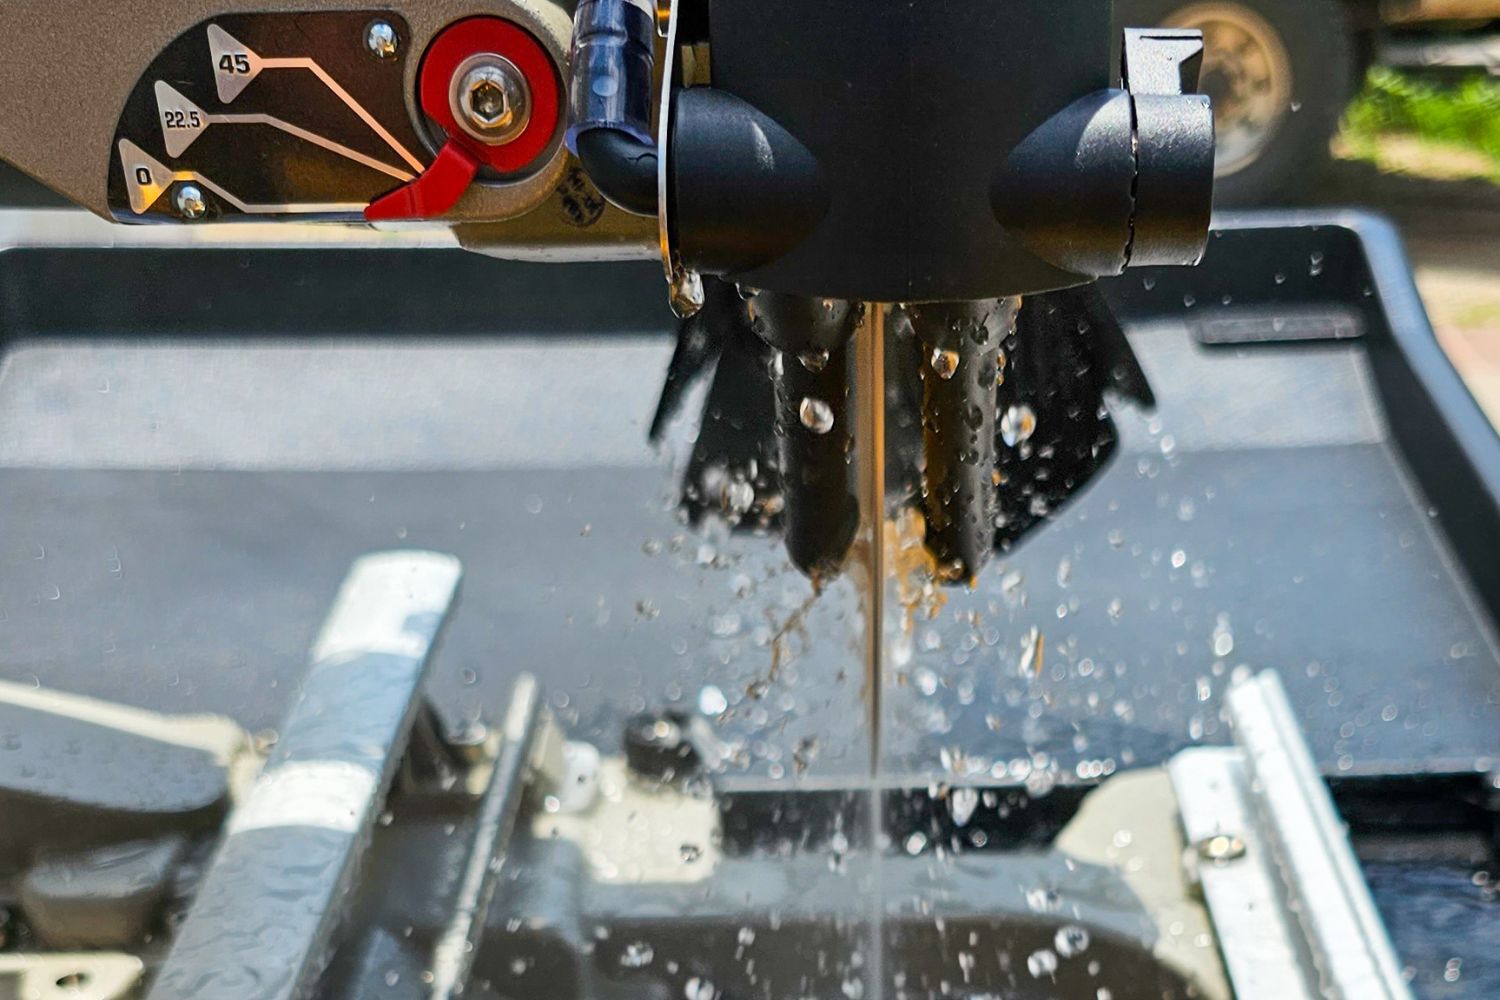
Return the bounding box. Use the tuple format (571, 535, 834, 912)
(428, 673, 542, 1000)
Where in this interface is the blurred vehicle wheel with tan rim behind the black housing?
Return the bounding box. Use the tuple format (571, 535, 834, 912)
(1116, 0, 1358, 205)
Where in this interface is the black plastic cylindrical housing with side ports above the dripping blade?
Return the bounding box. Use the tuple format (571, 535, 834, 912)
(666, 0, 1214, 301)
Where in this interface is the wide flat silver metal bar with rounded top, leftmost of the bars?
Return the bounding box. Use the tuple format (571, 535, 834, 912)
(149, 552, 462, 1000)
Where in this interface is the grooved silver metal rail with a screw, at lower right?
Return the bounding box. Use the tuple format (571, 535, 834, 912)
(1169, 672, 1412, 1000)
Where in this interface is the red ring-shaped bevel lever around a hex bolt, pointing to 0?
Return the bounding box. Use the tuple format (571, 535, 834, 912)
(365, 16, 563, 222)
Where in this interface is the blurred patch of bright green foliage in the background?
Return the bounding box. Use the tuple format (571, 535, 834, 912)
(1344, 66, 1500, 162)
